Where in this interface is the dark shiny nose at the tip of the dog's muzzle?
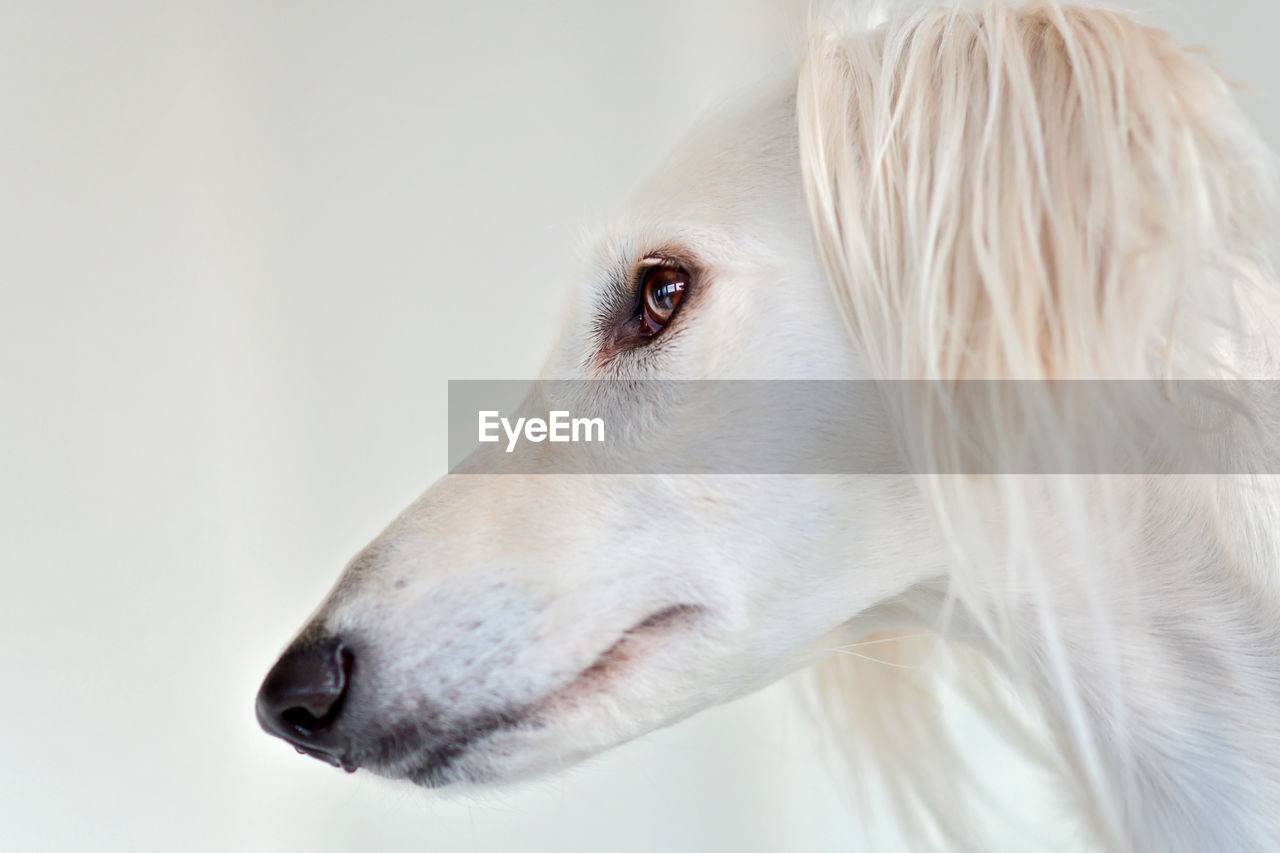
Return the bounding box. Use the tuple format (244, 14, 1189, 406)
(257, 639, 356, 771)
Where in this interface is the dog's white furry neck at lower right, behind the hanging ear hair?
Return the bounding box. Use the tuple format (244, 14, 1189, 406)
(940, 504, 1280, 852)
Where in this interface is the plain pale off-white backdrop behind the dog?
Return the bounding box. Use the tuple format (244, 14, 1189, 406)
(0, 0, 1280, 853)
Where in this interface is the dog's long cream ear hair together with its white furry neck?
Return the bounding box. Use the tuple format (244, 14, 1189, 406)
(797, 3, 1280, 850)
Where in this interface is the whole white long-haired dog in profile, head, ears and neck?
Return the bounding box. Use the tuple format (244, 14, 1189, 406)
(259, 4, 1280, 852)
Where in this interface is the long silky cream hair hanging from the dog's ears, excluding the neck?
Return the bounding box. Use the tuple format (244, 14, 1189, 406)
(797, 3, 1280, 849)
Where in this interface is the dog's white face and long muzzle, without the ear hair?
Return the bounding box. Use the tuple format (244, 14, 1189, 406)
(259, 78, 942, 785)
